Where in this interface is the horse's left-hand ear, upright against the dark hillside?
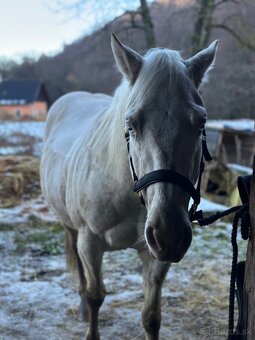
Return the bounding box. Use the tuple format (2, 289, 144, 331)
(111, 33, 143, 85)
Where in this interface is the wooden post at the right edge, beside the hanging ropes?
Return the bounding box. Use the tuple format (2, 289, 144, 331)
(244, 157, 255, 340)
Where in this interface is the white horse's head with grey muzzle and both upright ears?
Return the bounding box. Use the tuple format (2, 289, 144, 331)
(112, 35, 218, 262)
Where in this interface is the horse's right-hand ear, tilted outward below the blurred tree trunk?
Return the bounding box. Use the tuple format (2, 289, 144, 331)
(186, 40, 219, 88)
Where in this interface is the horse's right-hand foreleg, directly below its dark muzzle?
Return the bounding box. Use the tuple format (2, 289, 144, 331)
(139, 251, 170, 340)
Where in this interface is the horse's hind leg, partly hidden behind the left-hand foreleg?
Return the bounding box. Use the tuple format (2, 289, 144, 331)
(65, 226, 88, 321)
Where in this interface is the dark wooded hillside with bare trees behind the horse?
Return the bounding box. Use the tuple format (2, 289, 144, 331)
(0, 0, 255, 118)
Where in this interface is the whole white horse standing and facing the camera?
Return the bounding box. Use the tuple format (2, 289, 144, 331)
(41, 35, 217, 339)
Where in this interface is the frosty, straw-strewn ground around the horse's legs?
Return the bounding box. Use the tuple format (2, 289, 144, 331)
(0, 207, 246, 340)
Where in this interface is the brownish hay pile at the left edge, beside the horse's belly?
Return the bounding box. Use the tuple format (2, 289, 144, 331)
(0, 156, 40, 208)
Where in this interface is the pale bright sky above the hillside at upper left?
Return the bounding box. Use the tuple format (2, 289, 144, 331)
(0, 0, 145, 58)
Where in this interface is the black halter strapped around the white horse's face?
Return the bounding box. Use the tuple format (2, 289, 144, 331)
(125, 129, 212, 221)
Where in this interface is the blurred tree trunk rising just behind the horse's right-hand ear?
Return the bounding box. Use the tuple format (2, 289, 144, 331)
(191, 0, 214, 54)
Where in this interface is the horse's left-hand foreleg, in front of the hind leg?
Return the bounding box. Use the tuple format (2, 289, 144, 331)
(78, 227, 105, 340)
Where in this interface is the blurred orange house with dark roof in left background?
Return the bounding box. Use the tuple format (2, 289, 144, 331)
(0, 80, 49, 120)
